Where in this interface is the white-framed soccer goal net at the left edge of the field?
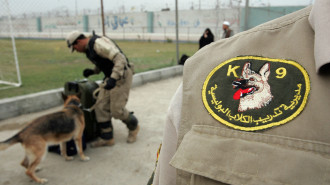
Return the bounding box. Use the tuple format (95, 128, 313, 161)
(0, 0, 22, 89)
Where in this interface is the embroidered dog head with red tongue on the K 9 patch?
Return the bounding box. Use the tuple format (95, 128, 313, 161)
(232, 62, 273, 112)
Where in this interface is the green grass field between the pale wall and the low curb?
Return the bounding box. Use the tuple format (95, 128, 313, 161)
(0, 39, 198, 99)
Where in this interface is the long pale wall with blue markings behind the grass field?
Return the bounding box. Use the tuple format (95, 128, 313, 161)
(0, 6, 304, 42)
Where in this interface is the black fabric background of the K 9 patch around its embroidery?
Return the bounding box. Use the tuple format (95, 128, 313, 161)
(205, 59, 306, 130)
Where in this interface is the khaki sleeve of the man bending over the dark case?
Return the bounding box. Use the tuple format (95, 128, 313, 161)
(94, 37, 127, 80)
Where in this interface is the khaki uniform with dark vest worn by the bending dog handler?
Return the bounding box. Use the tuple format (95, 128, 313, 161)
(86, 35, 137, 145)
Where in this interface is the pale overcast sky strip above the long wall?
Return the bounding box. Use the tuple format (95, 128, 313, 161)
(0, 0, 314, 14)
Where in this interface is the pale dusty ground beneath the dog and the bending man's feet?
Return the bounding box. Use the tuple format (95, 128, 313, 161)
(0, 76, 182, 185)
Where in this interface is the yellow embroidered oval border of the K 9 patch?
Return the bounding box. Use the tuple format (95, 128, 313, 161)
(202, 56, 310, 131)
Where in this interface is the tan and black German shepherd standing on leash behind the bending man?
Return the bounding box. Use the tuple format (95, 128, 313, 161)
(0, 93, 89, 184)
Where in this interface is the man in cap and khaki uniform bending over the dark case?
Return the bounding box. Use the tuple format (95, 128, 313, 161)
(66, 31, 139, 147)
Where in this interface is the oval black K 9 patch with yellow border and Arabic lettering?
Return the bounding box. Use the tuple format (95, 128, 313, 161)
(202, 56, 310, 131)
